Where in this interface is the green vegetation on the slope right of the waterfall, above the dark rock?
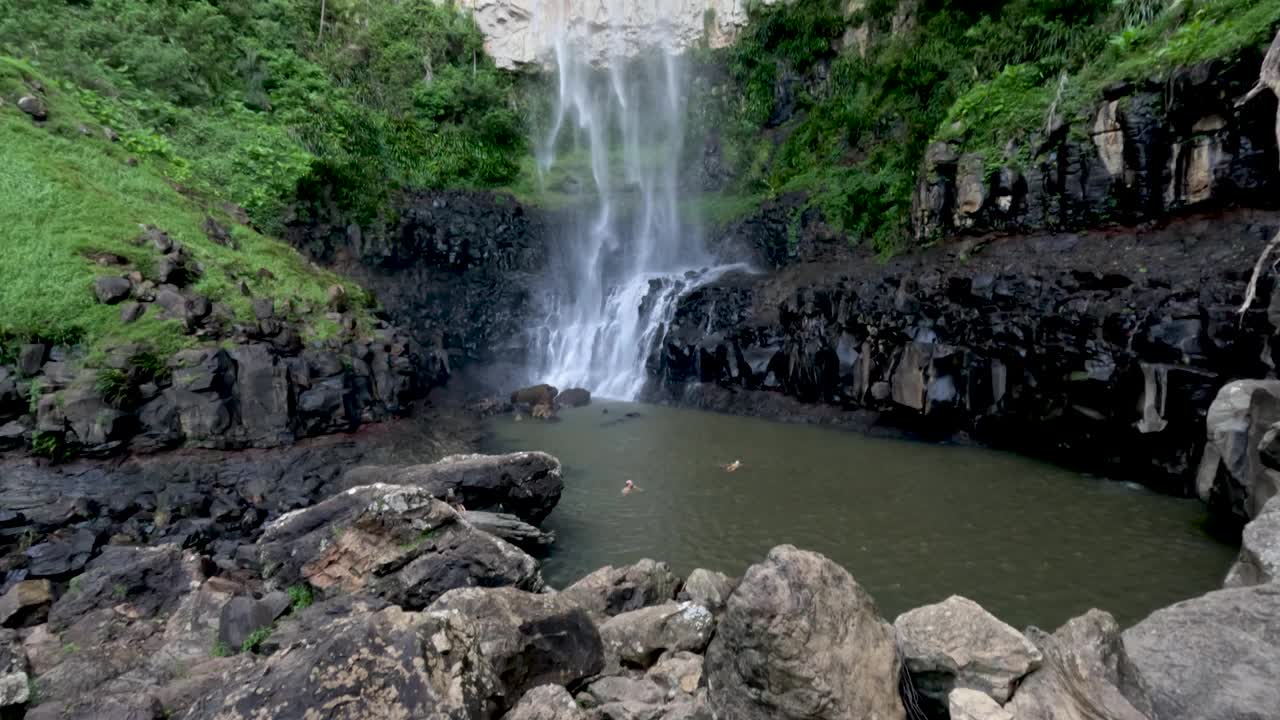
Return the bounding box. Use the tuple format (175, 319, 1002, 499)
(694, 0, 1280, 254)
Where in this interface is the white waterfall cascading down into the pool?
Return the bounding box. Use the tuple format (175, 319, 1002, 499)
(531, 9, 742, 400)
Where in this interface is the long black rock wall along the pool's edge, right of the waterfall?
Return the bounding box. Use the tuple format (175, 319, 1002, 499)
(646, 208, 1280, 495)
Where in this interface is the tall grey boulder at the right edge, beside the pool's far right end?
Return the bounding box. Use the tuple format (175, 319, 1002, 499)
(1196, 380, 1280, 520)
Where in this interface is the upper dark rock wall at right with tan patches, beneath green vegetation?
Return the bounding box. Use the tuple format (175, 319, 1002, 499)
(914, 53, 1280, 241)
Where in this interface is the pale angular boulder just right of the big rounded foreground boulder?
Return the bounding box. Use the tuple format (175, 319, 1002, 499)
(893, 596, 1042, 706)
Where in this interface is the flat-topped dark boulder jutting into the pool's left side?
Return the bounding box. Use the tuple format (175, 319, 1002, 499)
(343, 452, 564, 525)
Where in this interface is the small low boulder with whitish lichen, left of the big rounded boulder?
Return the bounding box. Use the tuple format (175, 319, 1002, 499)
(600, 602, 716, 671)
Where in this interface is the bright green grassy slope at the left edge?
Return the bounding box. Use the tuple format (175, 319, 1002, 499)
(0, 58, 360, 355)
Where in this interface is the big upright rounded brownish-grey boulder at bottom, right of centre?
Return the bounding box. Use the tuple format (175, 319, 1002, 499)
(705, 546, 905, 720)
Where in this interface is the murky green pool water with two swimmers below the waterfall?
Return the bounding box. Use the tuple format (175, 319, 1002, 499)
(486, 401, 1235, 628)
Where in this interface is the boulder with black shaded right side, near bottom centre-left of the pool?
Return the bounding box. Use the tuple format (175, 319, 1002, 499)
(429, 588, 604, 708)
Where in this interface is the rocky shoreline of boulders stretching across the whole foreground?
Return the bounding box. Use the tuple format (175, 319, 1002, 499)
(0, 388, 1280, 720)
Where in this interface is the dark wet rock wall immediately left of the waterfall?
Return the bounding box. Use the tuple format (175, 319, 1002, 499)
(288, 191, 553, 369)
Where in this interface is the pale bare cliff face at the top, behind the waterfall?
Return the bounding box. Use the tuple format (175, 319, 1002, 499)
(460, 0, 778, 69)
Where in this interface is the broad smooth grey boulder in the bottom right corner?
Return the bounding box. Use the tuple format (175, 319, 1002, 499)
(1124, 583, 1280, 720)
